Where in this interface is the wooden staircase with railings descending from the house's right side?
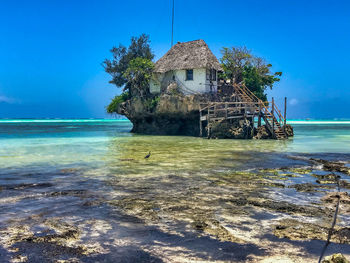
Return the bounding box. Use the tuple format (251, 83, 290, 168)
(234, 84, 288, 140)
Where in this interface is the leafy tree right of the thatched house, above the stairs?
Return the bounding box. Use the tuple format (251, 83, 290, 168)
(221, 47, 282, 101)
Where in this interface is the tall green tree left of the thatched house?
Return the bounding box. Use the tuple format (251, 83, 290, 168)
(102, 34, 154, 96)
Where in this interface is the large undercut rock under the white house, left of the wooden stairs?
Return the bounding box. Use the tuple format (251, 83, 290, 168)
(117, 95, 206, 136)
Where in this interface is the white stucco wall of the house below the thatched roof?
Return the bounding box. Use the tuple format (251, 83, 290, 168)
(150, 68, 217, 94)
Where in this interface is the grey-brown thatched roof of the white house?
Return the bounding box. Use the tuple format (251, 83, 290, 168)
(154, 39, 222, 73)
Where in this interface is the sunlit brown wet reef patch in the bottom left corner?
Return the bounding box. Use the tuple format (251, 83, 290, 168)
(0, 218, 91, 262)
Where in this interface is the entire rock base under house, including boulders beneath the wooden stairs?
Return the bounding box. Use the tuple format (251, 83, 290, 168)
(117, 84, 293, 139)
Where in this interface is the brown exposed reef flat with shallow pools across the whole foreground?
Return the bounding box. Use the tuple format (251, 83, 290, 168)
(0, 158, 350, 263)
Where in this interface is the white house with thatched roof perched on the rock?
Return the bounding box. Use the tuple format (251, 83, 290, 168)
(150, 40, 222, 94)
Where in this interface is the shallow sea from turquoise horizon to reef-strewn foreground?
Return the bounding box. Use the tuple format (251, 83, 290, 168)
(0, 119, 350, 262)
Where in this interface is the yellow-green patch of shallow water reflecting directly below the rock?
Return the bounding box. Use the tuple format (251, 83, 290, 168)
(105, 136, 290, 176)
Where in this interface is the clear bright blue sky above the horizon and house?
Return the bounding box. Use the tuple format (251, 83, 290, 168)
(0, 0, 350, 118)
